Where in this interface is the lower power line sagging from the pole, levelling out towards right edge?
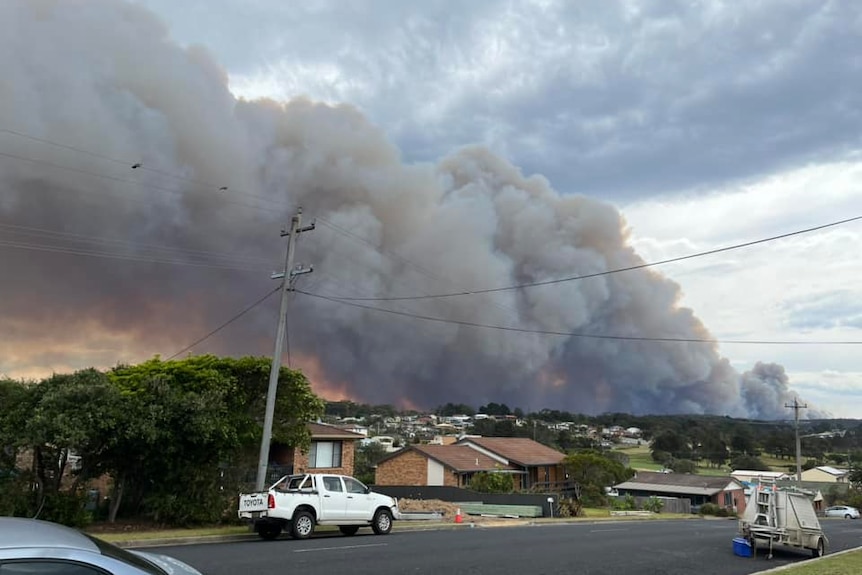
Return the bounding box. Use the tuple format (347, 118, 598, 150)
(294, 290, 862, 345)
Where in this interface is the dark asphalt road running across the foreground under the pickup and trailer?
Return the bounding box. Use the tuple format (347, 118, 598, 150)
(150, 519, 862, 575)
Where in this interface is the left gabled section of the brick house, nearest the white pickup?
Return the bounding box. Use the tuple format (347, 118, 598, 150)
(374, 445, 517, 487)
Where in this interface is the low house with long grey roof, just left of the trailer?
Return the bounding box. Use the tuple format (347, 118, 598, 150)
(614, 471, 745, 513)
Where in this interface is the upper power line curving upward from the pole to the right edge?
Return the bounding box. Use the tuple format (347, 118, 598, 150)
(324, 216, 862, 301)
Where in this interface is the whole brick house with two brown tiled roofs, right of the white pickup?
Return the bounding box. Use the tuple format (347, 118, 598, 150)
(375, 437, 566, 491)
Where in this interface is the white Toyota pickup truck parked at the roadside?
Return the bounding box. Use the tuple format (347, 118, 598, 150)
(238, 473, 400, 539)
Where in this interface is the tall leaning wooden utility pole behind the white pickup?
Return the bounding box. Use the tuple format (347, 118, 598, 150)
(255, 208, 314, 491)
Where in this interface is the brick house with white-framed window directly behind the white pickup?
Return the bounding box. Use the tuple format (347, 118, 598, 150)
(269, 423, 364, 475)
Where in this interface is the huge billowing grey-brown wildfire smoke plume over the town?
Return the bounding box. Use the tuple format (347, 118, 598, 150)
(0, 0, 820, 418)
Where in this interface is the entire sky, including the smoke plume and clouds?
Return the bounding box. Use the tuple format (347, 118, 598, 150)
(0, 0, 862, 418)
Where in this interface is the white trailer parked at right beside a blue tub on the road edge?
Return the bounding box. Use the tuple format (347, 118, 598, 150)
(739, 483, 828, 559)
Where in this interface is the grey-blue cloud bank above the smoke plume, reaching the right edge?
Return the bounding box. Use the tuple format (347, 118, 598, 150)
(133, 0, 862, 201)
